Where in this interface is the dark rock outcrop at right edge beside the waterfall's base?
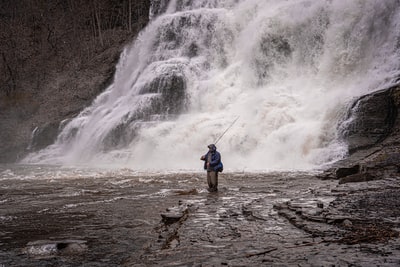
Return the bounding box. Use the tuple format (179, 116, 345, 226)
(334, 86, 400, 182)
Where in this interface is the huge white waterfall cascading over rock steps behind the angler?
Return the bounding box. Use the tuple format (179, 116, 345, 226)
(24, 0, 400, 171)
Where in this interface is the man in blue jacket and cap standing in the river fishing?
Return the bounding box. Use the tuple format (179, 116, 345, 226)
(200, 144, 223, 192)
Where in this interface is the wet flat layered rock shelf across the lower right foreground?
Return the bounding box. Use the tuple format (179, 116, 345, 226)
(137, 177, 400, 266)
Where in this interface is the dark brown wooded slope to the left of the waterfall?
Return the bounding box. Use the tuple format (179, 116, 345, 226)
(0, 0, 150, 162)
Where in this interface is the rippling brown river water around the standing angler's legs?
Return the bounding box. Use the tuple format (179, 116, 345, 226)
(0, 165, 342, 266)
